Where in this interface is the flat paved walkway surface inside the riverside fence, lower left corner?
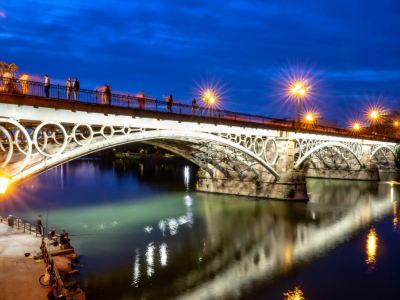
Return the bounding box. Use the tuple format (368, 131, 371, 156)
(0, 223, 49, 300)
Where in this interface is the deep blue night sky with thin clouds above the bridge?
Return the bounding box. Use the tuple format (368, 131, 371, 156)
(0, 0, 400, 124)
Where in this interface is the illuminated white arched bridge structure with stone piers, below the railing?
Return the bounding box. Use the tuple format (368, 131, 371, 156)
(0, 100, 396, 200)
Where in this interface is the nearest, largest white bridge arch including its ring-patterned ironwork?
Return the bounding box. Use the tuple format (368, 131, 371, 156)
(0, 118, 280, 186)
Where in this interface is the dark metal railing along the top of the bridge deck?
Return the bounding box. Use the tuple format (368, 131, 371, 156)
(0, 77, 399, 142)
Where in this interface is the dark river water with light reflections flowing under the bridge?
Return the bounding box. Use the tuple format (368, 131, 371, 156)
(0, 159, 400, 300)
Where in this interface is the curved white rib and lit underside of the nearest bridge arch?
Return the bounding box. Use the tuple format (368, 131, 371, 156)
(4, 120, 280, 188)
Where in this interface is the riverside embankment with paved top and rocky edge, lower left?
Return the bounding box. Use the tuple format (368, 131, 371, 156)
(0, 216, 86, 300)
